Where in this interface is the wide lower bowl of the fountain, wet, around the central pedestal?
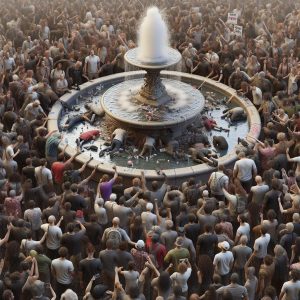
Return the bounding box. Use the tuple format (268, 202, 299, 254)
(101, 78, 205, 137)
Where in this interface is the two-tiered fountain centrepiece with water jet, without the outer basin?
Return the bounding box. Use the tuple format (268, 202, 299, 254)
(101, 7, 204, 137)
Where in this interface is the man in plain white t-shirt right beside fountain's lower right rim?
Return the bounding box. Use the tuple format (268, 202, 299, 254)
(233, 152, 257, 193)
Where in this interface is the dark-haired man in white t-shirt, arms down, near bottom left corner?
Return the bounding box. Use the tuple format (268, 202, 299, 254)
(51, 247, 74, 299)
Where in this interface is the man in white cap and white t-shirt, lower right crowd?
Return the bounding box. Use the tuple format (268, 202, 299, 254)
(213, 241, 234, 285)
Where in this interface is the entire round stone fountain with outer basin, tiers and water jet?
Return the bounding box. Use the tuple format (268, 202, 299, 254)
(48, 7, 261, 184)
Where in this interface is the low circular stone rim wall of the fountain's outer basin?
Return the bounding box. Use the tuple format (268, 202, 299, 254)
(48, 71, 261, 184)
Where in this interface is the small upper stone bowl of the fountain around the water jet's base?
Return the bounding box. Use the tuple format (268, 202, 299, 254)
(124, 47, 181, 70)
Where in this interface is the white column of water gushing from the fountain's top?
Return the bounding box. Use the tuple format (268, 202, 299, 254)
(138, 7, 169, 64)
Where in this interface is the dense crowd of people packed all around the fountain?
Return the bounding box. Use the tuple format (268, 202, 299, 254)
(0, 0, 300, 300)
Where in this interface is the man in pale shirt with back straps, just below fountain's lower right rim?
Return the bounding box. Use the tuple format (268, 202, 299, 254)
(208, 165, 229, 201)
